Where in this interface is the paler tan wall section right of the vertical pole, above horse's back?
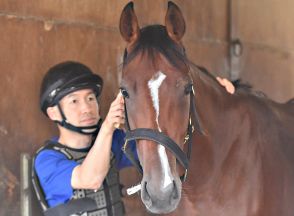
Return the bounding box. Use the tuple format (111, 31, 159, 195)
(235, 0, 294, 102)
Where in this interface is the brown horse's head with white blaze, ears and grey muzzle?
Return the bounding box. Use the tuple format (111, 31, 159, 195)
(120, 2, 191, 213)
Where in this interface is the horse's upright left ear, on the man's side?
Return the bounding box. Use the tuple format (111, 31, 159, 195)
(119, 2, 140, 43)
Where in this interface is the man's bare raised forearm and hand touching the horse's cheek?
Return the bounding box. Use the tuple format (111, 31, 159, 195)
(71, 94, 124, 189)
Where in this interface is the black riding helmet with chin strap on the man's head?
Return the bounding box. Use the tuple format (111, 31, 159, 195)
(40, 61, 103, 134)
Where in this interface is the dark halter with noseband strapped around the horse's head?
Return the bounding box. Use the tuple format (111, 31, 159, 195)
(121, 83, 203, 181)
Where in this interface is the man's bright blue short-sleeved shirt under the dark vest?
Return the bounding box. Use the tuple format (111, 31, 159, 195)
(35, 129, 138, 207)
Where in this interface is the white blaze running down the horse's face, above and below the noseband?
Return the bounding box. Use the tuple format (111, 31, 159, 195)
(148, 71, 172, 187)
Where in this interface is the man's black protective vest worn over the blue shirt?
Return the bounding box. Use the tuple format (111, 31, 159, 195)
(32, 141, 124, 216)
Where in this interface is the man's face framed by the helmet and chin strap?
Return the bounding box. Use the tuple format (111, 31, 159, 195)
(60, 89, 100, 127)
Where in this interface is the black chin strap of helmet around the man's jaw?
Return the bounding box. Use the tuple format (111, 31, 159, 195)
(54, 103, 102, 135)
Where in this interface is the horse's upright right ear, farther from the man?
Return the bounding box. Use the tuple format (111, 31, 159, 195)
(165, 1, 186, 42)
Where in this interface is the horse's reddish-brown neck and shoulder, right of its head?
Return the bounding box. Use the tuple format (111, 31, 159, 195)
(188, 71, 294, 215)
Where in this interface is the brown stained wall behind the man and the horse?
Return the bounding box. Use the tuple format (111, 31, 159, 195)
(0, 0, 294, 216)
